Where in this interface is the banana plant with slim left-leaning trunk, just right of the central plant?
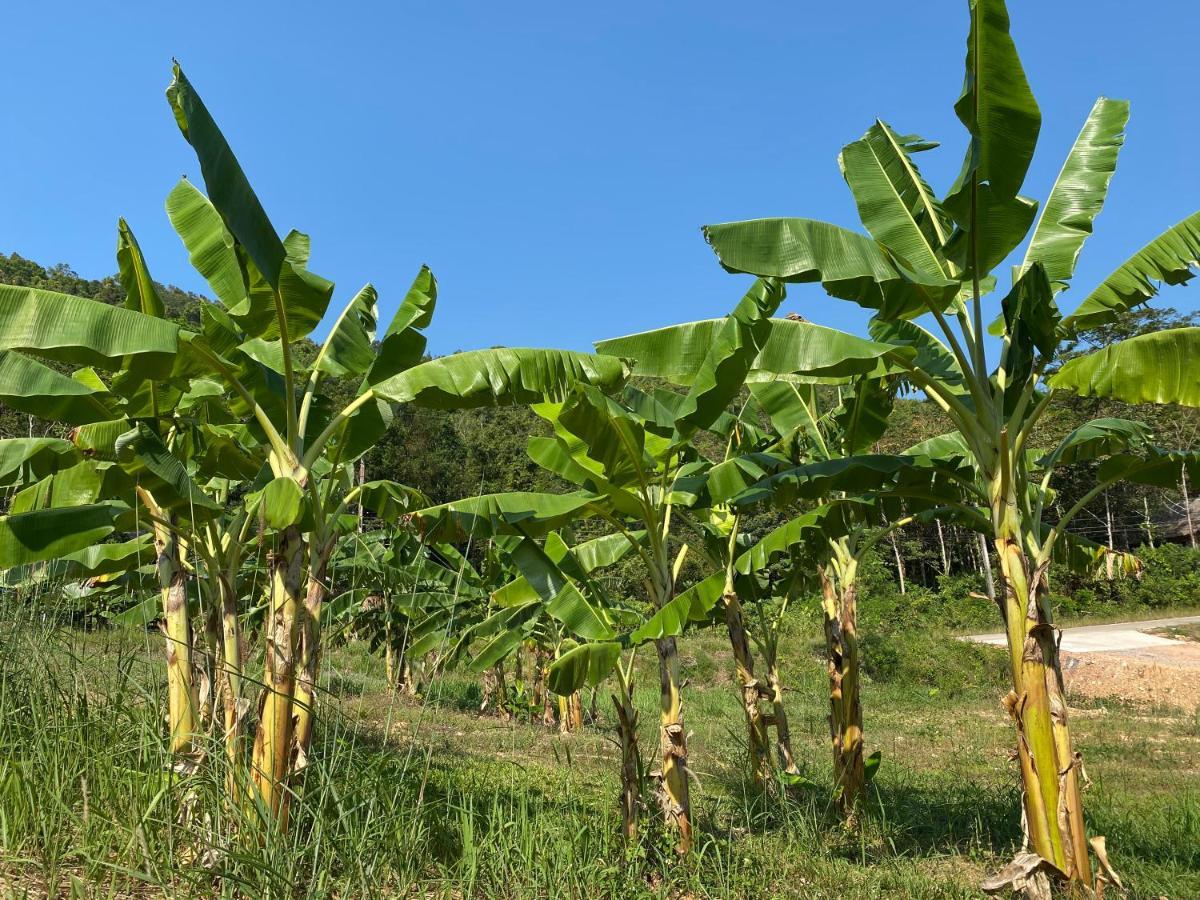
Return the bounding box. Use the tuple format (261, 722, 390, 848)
(596, 304, 916, 797)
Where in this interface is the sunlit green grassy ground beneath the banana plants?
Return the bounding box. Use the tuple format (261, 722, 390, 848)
(0, 609, 1200, 898)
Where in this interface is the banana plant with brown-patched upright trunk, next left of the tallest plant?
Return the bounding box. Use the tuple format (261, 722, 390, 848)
(657, 369, 966, 821)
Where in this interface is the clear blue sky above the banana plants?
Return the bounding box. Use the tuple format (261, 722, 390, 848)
(0, 0, 1200, 353)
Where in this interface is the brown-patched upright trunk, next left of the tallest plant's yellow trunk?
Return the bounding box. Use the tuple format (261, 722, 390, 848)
(821, 570, 866, 821)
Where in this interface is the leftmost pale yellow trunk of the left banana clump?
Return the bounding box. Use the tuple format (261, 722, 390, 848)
(155, 524, 197, 756)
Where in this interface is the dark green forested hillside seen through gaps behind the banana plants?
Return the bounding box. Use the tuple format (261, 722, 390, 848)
(0, 253, 1200, 600)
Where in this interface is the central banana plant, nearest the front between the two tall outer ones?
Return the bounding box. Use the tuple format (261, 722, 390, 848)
(405, 280, 784, 853)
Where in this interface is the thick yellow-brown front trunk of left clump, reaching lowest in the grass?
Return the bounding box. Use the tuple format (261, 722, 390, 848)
(254, 526, 305, 830)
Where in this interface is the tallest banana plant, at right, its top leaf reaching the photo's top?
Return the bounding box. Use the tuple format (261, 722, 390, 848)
(704, 0, 1200, 884)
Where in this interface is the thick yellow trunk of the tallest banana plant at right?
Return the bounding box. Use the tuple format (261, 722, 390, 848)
(995, 525, 1091, 884)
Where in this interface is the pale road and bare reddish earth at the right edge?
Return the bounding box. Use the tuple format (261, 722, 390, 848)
(966, 616, 1200, 712)
